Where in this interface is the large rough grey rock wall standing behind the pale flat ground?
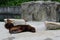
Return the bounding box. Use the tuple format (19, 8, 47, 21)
(21, 1, 58, 21)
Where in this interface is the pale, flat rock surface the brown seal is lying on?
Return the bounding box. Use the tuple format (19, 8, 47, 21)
(0, 22, 60, 40)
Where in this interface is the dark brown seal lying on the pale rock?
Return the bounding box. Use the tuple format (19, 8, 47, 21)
(5, 19, 35, 34)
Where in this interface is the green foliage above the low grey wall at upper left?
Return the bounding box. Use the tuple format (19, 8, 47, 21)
(0, 0, 35, 6)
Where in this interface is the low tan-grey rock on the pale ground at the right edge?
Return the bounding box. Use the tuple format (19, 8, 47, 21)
(45, 21, 60, 30)
